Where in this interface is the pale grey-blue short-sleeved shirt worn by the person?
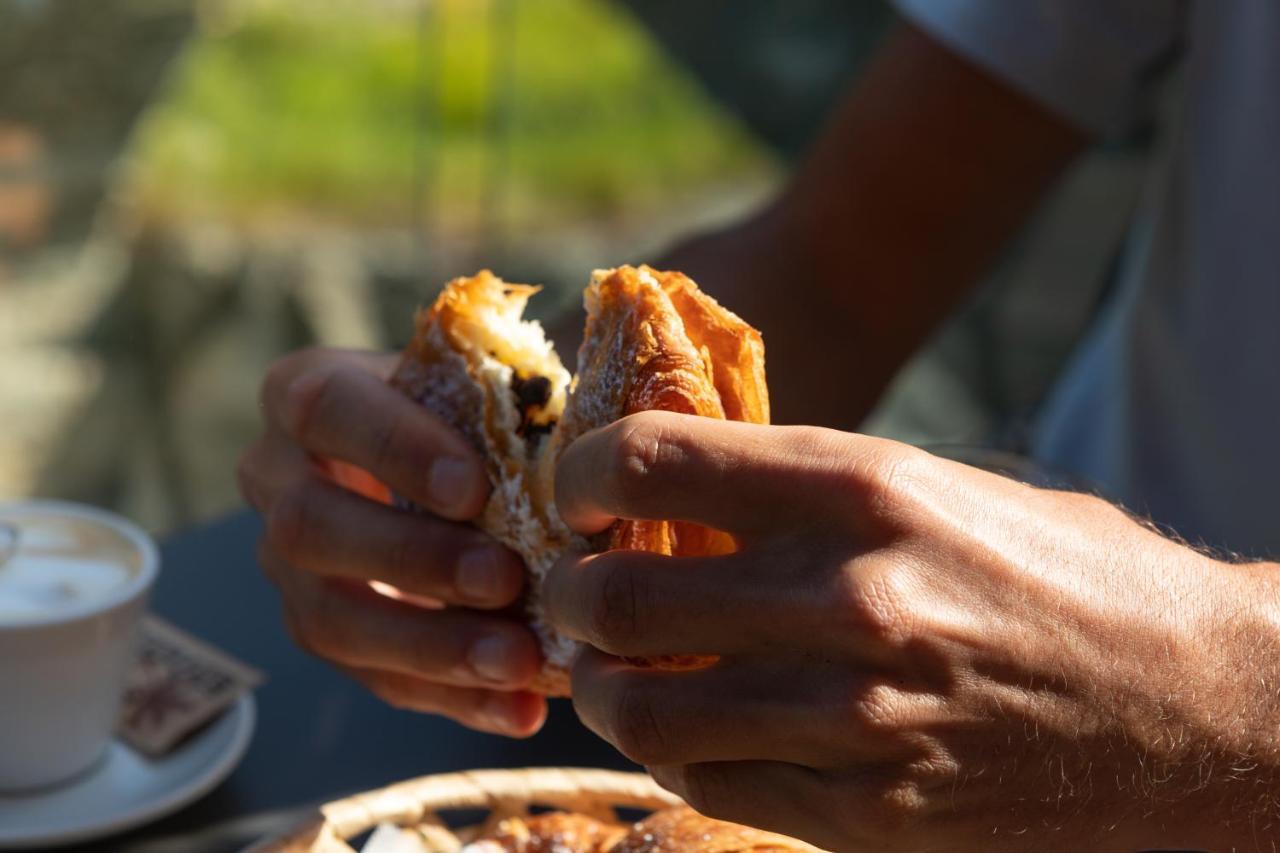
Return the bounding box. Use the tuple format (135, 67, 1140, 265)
(897, 0, 1280, 557)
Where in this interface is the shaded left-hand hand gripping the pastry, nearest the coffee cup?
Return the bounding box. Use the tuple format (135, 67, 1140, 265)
(238, 350, 547, 736)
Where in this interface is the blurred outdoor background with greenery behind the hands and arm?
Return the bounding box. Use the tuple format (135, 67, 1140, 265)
(0, 0, 1160, 532)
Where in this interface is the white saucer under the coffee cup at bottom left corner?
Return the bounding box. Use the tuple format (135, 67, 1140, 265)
(0, 693, 255, 850)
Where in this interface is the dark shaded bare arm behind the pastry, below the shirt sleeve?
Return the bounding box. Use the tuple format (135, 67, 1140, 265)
(662, 21, 1084, 428)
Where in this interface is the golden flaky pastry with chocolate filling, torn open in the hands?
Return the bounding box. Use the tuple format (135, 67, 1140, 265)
(392, 266, 769, 695)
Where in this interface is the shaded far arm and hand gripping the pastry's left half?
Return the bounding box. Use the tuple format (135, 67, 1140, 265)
(239, 19, 1082, 735)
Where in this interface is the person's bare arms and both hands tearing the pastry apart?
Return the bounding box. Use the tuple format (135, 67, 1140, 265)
(241, 21, 1280, 852)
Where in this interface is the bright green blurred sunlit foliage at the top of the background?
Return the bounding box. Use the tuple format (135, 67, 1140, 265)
(133, 0, 769, 229)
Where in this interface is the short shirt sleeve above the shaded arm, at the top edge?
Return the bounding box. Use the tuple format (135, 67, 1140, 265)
(893, 0, 1187, 136)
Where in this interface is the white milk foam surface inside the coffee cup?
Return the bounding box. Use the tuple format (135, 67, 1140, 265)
(0, 514, 140, 622)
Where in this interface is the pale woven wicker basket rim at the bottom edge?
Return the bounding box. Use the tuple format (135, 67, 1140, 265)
(246, 767, 681, 853)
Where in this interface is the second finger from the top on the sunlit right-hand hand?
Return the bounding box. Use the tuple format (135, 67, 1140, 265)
(541, 540, 841, 657)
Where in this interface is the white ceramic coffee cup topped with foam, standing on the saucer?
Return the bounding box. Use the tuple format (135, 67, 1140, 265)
(0, 501, 160, 792)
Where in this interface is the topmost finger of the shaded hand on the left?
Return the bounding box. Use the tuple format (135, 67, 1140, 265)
(266, 364, 489, 520)
